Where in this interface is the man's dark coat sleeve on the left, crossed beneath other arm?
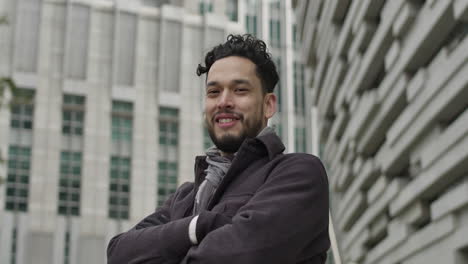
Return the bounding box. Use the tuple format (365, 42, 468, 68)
(107, 184, 231, 264)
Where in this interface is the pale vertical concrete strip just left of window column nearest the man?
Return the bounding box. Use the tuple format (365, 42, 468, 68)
(130, 15, 159, 222)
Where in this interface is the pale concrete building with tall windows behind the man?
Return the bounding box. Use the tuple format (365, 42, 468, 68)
(0, 0, 310, 264)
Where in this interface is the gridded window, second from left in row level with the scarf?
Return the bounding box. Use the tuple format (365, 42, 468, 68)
(58, 151, 81, 216)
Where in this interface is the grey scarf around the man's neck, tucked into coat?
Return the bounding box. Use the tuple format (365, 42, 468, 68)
(193, 126, 275, 214)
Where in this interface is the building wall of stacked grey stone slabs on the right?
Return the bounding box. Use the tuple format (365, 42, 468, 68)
(293, 0, 468, 264)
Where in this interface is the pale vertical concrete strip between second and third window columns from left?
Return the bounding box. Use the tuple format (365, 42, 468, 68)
(81, 6, 114, 234)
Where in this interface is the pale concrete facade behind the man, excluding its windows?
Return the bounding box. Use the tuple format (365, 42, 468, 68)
(0, 0, 302, 264)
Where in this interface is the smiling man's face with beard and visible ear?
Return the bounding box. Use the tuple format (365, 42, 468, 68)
(205, 56, 276, 153)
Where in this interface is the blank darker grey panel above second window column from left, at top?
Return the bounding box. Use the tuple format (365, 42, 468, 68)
(67, 4, 90, 80)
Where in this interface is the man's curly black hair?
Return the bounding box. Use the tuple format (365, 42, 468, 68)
(197, 34, 279, 93)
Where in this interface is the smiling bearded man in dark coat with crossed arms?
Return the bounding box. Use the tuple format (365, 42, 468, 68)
(107, 35, 330, 264)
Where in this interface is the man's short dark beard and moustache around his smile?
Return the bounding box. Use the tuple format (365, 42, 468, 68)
(205, 111, 263, 153)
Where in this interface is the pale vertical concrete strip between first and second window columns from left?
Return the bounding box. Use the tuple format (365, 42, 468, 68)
(29, 2, 66, 233)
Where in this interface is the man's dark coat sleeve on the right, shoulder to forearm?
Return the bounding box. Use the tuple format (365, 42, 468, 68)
(183, 154, 330, 264)
